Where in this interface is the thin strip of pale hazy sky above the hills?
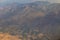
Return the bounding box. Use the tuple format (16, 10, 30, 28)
(0, 0, 60, 3)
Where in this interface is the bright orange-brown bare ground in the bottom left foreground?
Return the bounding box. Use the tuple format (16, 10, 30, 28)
(0, 33, 21, 40)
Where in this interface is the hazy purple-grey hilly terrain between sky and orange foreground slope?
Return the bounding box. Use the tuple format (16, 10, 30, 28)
(0, 1, 60, 40)
